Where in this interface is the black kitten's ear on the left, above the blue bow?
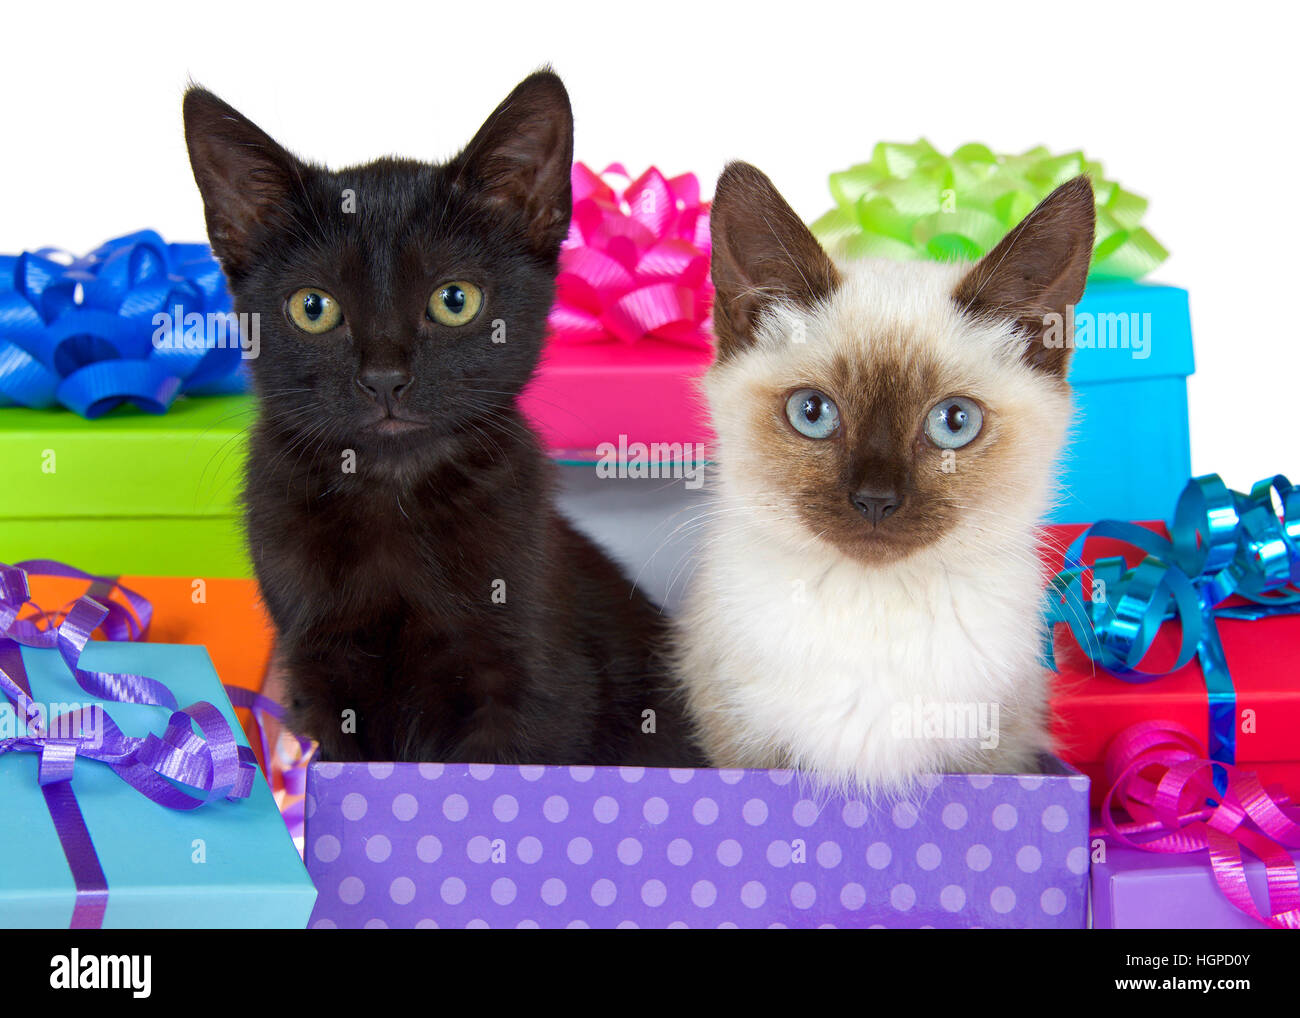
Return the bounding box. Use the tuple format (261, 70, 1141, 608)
(183, 86, 303, 276)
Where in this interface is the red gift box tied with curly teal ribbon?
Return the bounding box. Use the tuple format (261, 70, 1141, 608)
(1043, 523, 1300, 805)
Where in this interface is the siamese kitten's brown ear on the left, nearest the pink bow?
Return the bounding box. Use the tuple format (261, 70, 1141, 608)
(710, 163, 840, 358)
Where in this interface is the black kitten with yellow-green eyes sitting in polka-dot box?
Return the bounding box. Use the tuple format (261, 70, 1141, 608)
(185, 72, 702, 766)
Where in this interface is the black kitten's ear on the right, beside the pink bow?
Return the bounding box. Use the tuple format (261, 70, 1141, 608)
(455, 70, 573, 257)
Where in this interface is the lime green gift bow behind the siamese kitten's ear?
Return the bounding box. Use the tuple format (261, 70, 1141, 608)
(813, 139, 1169, 280)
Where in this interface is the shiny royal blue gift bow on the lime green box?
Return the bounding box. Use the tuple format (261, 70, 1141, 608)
(0, 230, 243, 417)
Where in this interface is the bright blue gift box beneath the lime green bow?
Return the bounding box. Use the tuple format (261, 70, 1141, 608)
(1049, 281, 1195, 523)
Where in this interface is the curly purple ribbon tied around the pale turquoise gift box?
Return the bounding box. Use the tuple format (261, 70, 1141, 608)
(0, 560, 257, 930)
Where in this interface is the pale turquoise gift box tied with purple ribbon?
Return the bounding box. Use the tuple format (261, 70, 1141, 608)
(0, 641, 316, 928)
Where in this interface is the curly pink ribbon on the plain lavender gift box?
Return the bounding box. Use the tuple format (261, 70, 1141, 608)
(1092, 720, 1300, 930)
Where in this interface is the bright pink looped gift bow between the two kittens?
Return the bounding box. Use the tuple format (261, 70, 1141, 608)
(549, 163, 712, 348)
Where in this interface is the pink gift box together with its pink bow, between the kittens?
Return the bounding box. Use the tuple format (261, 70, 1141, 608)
(520, 163, 712, 462)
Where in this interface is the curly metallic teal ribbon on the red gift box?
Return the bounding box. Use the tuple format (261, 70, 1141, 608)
(1044, 473, 1300, 764)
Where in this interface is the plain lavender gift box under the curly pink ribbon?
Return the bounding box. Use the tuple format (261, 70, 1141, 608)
(1092, 840, 1300, 930)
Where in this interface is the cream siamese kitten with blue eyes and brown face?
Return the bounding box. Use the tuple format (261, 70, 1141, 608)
(679, 163, 1095, 794)
